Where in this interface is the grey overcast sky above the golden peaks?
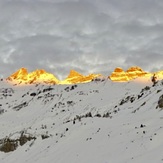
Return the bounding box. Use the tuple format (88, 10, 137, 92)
(0, 0, 163, 79)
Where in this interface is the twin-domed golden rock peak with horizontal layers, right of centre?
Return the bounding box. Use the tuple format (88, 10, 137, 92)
(109, 66, 152, 82)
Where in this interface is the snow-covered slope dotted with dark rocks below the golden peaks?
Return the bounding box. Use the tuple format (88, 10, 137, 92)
(0, 78, 163, 163)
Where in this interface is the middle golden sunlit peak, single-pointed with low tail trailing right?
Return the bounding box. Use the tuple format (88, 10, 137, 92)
(61, 70, 101, 84)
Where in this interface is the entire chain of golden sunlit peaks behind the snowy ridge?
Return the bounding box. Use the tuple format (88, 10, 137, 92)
(7, 66, 163, 85)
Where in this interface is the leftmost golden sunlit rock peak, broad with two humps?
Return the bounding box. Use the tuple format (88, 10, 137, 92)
(7, 68, 59, 84)
